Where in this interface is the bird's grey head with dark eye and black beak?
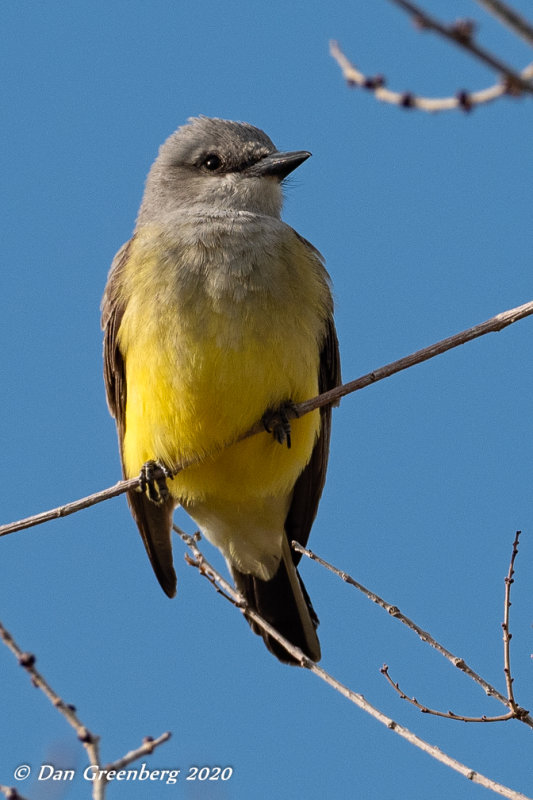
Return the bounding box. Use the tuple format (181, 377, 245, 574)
(137, 117, 311, 225)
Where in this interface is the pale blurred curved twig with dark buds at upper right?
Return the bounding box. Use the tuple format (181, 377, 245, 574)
(330, 41, 533, 114)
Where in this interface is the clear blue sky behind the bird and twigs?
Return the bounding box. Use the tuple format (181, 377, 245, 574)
(0, 0, 533, 800)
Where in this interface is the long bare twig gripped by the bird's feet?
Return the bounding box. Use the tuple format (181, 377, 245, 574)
(0, 301, 533, 536)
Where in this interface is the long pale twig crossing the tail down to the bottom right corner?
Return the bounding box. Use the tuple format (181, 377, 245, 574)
(174, 525, 531, 800)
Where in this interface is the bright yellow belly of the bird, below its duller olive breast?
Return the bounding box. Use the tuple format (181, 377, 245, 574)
(123, 316, 320, 506)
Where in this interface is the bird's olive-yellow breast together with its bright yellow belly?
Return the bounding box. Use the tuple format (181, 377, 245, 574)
(119, 226, 329, 503)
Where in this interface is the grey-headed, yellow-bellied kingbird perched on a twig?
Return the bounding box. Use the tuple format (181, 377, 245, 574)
(102, 117, 340, 663)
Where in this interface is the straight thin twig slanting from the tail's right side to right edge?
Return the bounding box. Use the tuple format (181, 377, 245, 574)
(291, 541, 533, 728)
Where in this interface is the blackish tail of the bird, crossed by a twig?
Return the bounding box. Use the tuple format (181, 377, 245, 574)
(231, 535, 320, 664)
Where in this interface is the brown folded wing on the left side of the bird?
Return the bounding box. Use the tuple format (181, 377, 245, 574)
(98, 239, 176, 597)
